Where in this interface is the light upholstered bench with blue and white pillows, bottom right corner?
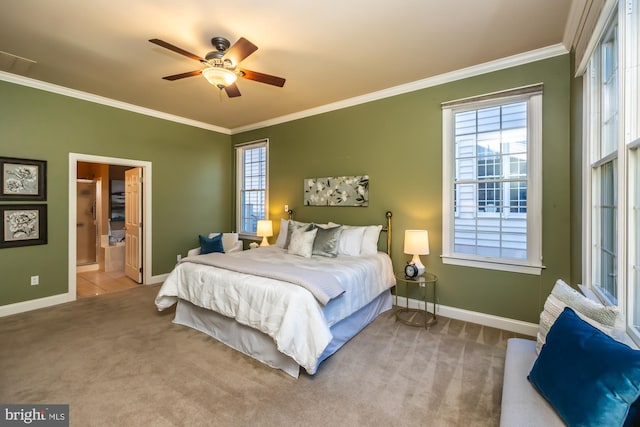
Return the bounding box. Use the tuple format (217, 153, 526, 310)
(500, 280, 640, 427)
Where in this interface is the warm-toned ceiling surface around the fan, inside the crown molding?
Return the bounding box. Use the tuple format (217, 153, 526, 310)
(0, 0, 571, 130)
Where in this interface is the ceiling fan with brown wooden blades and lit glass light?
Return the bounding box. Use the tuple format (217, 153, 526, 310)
(149, 37, 285, 98)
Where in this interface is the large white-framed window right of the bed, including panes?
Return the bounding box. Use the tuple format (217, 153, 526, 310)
(443, 85, 542, 274)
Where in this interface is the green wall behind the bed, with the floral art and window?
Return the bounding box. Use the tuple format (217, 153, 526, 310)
(232, 55, 571, 323)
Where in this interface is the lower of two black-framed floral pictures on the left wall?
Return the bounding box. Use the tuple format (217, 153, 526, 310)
(0, 204, 47, 248)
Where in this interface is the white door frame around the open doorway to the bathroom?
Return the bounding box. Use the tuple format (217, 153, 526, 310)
(68, 153, 152, 301)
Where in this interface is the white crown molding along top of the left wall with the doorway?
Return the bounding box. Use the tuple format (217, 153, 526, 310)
(0, 71, 231, 135)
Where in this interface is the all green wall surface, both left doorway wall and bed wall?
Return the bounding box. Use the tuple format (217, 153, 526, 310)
(0, 55, 580, 323)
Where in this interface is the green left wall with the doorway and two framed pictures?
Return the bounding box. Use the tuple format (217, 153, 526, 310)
(0, 82, 233, 305)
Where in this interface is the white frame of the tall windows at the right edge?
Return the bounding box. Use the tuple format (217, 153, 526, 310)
(576, 0, 640, 345)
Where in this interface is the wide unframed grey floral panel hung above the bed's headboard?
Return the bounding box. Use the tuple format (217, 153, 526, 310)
(304, 175, 369, 206)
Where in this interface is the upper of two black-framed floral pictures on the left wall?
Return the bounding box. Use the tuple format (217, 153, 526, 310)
(0, 157, 47, 201)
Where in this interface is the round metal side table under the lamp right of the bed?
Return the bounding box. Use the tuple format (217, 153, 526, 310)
(396, 272, 438, 328)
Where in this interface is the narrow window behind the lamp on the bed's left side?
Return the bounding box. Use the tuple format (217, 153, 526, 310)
(236, 139, 269, 235)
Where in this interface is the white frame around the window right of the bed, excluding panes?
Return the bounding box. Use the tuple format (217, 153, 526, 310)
(442, 84, 544, 275)
